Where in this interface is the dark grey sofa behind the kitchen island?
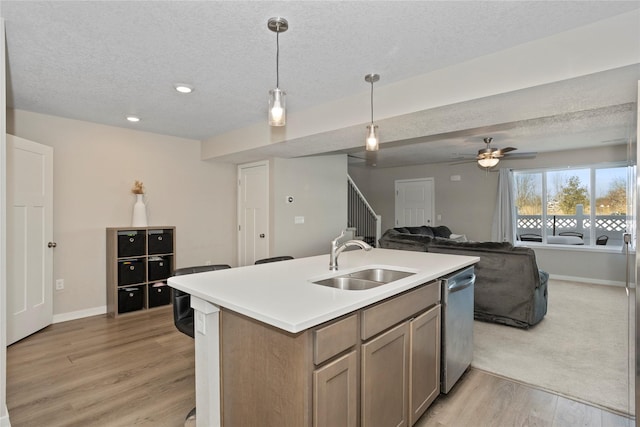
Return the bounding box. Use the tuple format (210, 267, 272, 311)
(379, 226, 549, 328)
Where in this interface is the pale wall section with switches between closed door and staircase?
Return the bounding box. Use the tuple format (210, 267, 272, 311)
(270, 155, 347, 258)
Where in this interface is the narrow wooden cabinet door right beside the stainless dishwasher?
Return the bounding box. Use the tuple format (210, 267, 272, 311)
(409, 305, 440, 425)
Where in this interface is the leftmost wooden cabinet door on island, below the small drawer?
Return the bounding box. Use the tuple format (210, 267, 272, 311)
(313, 351, 358, 427)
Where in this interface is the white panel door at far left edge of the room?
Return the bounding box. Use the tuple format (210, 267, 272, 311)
(7, 135, 55, 344)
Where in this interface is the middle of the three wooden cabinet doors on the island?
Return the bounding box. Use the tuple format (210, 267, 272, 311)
(361, 322, 409, 427)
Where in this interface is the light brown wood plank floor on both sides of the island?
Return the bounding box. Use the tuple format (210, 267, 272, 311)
(7, 307, 634, 427)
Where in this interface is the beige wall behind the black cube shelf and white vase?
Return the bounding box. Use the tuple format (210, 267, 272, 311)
(7, 110, 237, 320)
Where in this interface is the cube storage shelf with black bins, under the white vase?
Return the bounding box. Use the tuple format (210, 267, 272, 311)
(107, 227, 176, 317)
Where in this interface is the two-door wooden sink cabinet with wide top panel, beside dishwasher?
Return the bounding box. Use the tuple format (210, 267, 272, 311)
(361, 282, 440, 427)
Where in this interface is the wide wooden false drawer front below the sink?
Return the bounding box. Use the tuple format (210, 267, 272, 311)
(361, 280, 440, 340)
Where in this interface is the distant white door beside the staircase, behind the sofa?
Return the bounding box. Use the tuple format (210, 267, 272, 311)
(396, 178, 434, 227)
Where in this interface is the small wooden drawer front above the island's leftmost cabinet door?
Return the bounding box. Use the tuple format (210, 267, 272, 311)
(313, 314, 358, 365)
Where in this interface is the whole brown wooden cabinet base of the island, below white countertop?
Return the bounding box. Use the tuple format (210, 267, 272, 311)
(220, 281, 440, 427)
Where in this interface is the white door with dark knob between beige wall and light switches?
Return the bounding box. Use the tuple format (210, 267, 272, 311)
(238, 162, 269, 266)
